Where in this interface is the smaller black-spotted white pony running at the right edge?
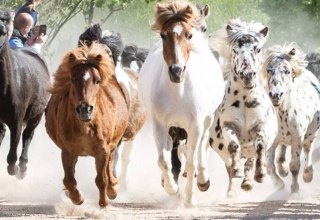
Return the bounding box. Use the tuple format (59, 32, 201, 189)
(263, 43, 320, 193)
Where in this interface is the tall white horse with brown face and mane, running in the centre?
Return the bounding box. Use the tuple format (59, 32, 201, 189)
(138, 1, 224, 206)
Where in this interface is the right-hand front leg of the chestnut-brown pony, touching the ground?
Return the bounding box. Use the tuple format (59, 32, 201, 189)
(95, 152, 112, 208)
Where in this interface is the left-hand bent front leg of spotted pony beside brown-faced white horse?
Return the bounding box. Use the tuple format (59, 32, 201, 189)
(222, 125, 243, 178)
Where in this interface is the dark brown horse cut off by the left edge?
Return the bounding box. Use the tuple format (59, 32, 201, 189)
(0, 10, 50, 178)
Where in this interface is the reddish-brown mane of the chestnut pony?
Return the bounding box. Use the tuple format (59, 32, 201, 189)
(50, 42, 115, 94)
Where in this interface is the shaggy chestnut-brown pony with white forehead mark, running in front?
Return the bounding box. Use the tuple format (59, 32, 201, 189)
(46, 43, 129, 207)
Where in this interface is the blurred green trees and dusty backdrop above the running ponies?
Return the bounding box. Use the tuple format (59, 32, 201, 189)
(0, 0, 320, 69)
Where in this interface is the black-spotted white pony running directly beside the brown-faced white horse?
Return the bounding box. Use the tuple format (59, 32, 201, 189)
(209, 19, 278, 196)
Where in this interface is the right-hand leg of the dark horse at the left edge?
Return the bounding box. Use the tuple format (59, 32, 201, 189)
(16, 113, 43, 179)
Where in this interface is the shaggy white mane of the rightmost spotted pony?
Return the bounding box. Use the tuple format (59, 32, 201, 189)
(263, 42, 308, 76)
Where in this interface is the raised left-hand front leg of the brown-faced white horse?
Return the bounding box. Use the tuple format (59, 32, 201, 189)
(153, 121, 178, 195)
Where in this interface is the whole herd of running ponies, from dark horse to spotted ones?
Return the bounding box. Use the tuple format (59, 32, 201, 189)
(0, 1, 320, 207)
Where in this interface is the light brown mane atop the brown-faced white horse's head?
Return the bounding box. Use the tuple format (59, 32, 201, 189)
(151, 1, 201, 31)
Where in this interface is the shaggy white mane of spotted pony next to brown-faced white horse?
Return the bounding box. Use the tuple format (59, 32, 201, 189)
(209, 19, 266, 79)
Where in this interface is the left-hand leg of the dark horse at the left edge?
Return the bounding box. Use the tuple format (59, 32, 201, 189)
(7, 121, 22, 176)
